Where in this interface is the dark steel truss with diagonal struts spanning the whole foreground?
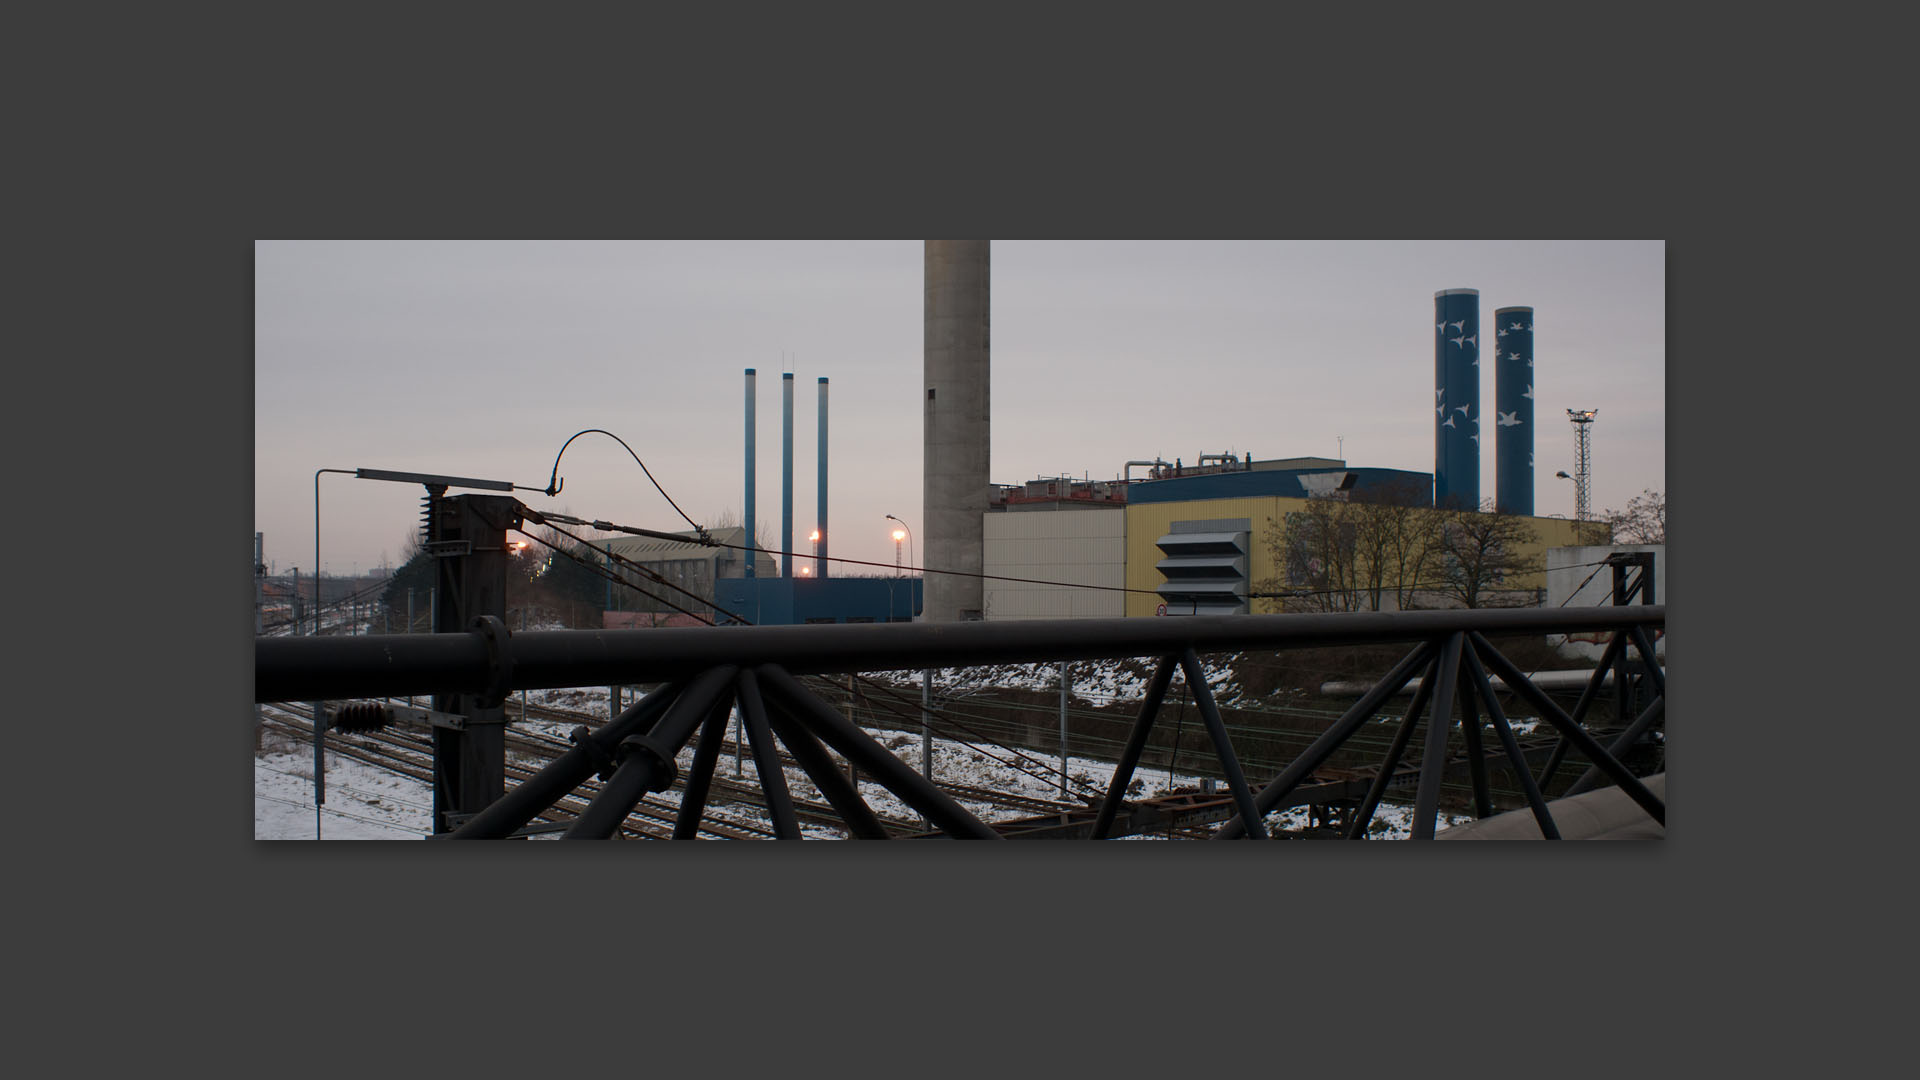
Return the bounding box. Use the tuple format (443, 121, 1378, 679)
(255, 605, 1667, 840)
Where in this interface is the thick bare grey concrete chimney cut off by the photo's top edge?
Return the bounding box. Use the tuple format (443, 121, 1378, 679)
(920, 240, 993, 623)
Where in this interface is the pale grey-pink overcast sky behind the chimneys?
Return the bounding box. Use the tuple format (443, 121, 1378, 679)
(253, 240, 1667, 575)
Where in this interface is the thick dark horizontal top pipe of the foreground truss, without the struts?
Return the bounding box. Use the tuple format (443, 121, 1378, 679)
(253, 603, 1667, 701)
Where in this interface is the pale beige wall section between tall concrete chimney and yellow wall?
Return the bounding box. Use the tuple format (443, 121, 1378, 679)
(990, 509, 1127, 619)
